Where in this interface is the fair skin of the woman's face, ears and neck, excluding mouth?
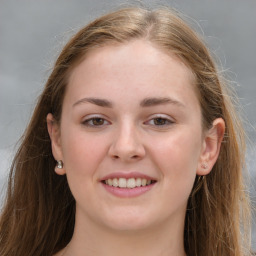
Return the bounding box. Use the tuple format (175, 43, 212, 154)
(47, 40, 225, 256)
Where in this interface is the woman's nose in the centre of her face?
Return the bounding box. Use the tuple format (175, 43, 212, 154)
(109, 123, 145, 162)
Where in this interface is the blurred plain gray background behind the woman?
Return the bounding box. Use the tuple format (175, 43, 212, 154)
(0, 0, 256, 247)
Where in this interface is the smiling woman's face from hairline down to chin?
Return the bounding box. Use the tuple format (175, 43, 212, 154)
(49, 40, 212, 230)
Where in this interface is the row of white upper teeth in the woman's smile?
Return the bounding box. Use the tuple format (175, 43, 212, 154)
(105, 178, 152, 188)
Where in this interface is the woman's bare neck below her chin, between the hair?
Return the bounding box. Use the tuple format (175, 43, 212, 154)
(60, 209, 186, 256)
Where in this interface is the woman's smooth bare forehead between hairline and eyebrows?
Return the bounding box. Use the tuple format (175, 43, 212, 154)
(67, 40, 198, 107)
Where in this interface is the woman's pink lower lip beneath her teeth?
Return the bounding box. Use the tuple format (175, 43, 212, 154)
(102, 183, 156, 198)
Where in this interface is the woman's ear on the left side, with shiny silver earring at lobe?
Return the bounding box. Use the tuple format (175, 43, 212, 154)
(46, 113, 66, 175)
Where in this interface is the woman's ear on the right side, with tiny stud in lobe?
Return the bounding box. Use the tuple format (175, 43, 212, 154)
(197, 118, 225, 176)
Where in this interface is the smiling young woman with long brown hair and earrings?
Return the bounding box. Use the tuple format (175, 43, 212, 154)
(0, 8, 252, 256)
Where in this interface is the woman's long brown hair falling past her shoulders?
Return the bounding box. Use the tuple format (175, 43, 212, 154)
(0, 8, 250, 256)
